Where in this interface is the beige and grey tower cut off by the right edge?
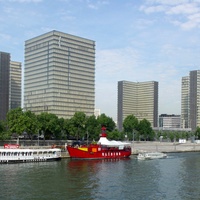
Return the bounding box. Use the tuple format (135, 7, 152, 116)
(181, 70, 200, 130)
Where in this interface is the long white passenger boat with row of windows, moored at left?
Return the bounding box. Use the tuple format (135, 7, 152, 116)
(0, 145, 61, 164)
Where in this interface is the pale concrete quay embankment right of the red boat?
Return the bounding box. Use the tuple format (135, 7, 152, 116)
(132, 142, 200, 154)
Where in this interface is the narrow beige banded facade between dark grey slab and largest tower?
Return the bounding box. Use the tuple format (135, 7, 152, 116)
(9, 61, 22, 109)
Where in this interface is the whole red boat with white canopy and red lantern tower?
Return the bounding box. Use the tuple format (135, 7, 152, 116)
(67, 127, 131, 159)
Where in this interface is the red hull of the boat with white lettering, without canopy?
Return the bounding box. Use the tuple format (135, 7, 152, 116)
(67, 145, 131, 159)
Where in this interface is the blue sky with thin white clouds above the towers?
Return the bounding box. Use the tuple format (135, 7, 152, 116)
(0, 0, 200, 120)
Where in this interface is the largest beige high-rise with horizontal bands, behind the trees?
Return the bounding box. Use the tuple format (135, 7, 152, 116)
(24, 30, 95, 118)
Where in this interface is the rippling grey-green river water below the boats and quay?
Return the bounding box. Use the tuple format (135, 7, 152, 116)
(0, 152, 200, 200)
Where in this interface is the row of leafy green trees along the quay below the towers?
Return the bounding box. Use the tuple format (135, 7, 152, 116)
(0, 108, 155, 140)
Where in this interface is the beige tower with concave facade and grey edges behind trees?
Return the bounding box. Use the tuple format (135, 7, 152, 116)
(117, 81, 158, 131)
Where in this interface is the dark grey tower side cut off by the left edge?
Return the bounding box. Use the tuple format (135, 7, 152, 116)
(0, 52, 10, 120)
